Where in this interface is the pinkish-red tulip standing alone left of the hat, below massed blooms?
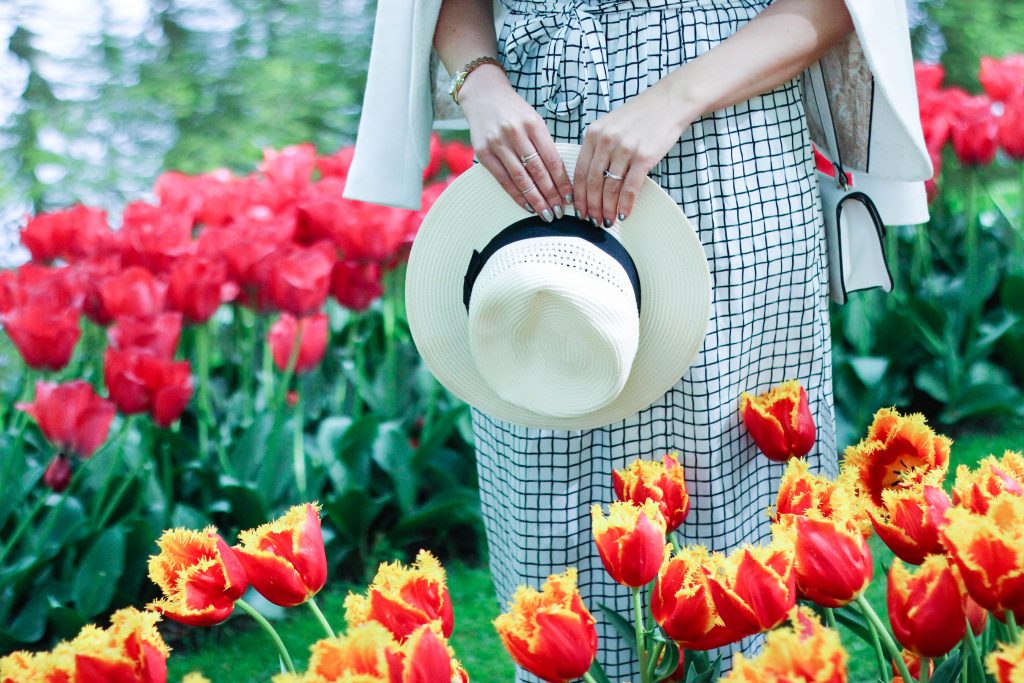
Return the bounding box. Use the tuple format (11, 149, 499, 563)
(269, 242, 335, 317)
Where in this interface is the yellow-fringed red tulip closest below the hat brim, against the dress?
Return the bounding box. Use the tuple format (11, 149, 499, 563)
(611, 453, 690, 532)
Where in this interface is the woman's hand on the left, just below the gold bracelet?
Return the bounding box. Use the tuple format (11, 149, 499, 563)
(459, 65, 572, 222)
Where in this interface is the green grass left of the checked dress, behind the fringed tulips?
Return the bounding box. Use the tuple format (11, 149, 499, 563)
(168, 562, 514, 683)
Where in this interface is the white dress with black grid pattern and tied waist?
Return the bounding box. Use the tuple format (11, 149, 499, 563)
(473, 0, 838, 683)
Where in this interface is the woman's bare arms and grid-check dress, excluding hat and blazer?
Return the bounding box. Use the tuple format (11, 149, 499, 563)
(434, 0, 852, 681)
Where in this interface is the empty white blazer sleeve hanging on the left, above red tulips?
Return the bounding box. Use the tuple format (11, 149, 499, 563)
(342, 0, 441, 211)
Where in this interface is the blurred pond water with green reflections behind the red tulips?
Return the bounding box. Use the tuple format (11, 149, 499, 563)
(0, 0, 374, 265)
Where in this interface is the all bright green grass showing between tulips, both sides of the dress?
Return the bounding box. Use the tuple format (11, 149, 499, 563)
(168, 422, 1024, 683)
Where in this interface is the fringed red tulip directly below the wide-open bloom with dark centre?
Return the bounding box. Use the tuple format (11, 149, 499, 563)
(867, 470, 951, 564)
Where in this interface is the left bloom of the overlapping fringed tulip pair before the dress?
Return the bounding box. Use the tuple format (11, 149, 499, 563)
(650, 545, 750, 650)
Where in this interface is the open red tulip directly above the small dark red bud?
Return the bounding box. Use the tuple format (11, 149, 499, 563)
(17, 380, 116, 458)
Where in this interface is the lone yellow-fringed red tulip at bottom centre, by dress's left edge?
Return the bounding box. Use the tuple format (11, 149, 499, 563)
(494, 567, 597, 683)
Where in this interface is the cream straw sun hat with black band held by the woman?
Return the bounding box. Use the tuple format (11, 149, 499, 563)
(406, 142, 711, 429)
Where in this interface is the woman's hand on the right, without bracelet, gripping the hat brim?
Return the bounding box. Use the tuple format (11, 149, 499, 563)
(572, 82, 695, 227)
